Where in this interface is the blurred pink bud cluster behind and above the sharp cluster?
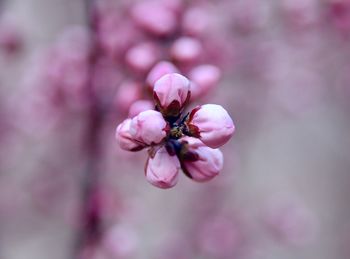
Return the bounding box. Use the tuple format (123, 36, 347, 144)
(91, 0, 226, 114)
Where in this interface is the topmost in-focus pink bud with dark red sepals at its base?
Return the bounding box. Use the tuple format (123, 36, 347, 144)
(153, 73, 190, 116)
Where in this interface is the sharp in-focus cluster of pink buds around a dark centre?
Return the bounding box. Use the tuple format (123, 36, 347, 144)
(116, 73, 235, 189)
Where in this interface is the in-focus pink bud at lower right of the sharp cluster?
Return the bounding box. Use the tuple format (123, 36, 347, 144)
(181, 137, 224, 182)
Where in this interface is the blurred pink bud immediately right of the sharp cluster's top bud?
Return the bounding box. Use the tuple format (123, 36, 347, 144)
(189, 65, 221, 99)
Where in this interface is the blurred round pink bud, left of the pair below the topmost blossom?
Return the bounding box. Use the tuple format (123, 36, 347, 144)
(125, 42, 159, 73)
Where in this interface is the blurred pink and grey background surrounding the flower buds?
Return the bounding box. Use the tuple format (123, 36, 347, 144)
(0, 0, 350, 259)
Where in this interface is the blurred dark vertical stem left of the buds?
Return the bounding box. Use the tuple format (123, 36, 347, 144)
(75, 0, 104, 258)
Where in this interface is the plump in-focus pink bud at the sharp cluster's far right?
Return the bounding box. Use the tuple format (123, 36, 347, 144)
(186, 104, 235, 148)
